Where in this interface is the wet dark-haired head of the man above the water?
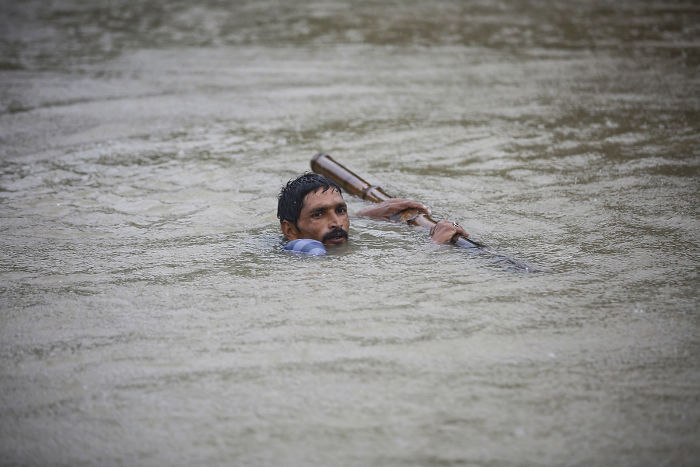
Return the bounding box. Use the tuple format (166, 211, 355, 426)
(277, 173, 350, 245)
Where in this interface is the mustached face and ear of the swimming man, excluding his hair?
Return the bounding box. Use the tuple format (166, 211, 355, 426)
(282, 188, 350, 245)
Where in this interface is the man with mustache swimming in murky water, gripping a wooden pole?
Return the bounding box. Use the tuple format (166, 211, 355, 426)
(277, 173, 468, 254)
